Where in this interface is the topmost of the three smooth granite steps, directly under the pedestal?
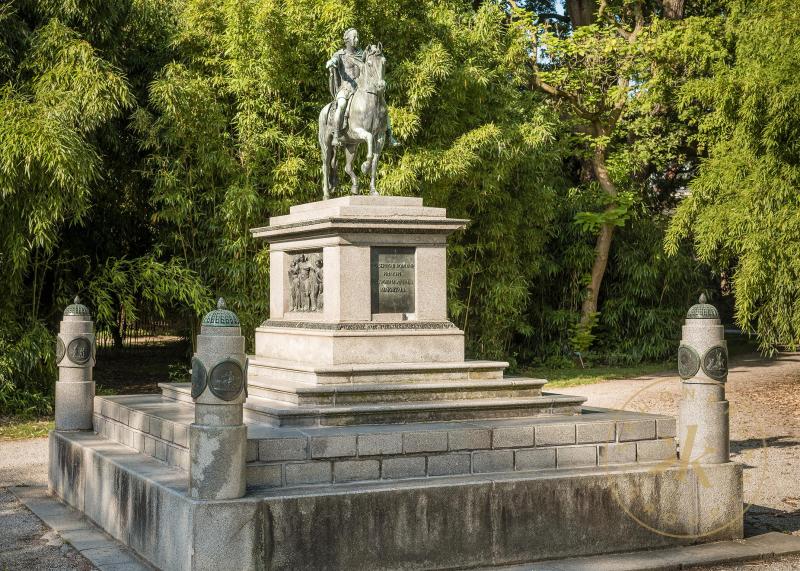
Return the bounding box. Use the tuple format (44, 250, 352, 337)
(248, 355, 508, 385)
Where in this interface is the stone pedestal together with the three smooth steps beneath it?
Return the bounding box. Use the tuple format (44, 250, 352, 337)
(245, 196, 583, 426)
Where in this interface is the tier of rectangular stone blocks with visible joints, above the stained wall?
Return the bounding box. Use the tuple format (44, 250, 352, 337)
(95, 395, 676, 488)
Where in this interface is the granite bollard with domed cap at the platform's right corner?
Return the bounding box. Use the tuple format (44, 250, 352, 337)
(678, 295, 730, 464)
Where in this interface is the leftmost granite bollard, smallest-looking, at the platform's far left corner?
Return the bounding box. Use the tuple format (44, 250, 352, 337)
(55, 297, 96, 430)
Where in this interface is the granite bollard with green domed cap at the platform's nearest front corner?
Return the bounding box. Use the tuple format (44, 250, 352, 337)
(189, 298, 247, 500)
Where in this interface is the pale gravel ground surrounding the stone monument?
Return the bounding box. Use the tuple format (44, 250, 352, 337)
(0, 353, 800, 571)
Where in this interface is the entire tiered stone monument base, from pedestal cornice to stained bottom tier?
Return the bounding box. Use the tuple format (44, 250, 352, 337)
(45, 196, 742, 571)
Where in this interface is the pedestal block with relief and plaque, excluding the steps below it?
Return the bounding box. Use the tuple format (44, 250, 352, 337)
(252, 196, 467, 365)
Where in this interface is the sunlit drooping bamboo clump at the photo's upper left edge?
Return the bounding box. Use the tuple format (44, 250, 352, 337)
(0, 16, 131, 304)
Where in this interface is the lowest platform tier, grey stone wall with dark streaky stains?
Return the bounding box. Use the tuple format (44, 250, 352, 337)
(50, 431, 742, 570)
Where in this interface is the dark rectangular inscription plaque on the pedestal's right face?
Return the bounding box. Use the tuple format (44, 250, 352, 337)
(370, 246, 416, 313)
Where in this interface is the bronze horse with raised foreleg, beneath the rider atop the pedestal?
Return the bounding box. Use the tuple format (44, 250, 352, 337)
(319, 44, 388, 199)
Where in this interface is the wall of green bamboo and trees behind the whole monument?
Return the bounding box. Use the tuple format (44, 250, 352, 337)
(0, 0, 800, 388)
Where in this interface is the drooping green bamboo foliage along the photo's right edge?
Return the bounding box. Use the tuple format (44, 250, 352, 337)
(667, 0, 800, 352)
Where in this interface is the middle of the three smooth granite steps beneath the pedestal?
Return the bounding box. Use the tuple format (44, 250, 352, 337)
(248, 377, 547, 406)
